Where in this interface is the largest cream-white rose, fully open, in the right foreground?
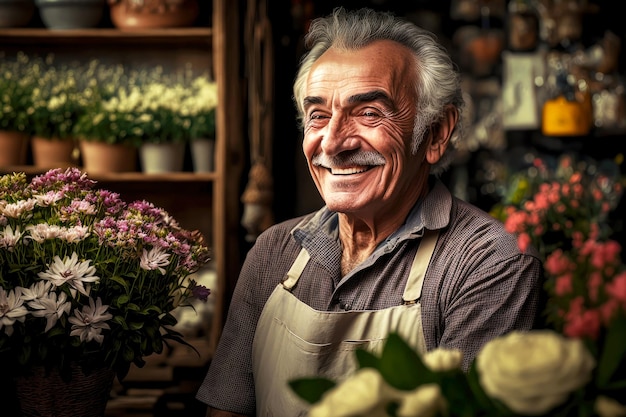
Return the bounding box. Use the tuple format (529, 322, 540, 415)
(476, 330, 595, 415)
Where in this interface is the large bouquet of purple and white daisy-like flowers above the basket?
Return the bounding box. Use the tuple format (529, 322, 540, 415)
(0, 168, 210, 380)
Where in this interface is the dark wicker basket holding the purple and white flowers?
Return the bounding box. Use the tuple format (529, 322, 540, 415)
(16, 366, 115, 417)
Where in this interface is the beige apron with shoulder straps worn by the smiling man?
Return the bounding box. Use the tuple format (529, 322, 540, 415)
(252, 231, 438, 417)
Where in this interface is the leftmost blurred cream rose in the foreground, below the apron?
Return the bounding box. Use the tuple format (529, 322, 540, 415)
(308, 368, 399, 417)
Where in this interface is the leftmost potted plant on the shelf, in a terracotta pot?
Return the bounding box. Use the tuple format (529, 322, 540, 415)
(0, 53, 35, 166)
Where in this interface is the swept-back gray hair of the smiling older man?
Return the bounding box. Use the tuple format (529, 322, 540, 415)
(293, 7, 464, 175)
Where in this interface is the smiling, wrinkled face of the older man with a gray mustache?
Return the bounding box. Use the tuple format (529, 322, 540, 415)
(302, 41, 432, 219)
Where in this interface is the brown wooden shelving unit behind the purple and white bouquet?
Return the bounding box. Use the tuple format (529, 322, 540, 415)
(0, 0, 246, 412)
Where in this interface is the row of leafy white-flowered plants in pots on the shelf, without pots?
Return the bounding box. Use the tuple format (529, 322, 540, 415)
(0, 53, 217, 146)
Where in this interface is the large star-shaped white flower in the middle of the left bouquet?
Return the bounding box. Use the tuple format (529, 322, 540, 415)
(37, 252, 100, 295)
